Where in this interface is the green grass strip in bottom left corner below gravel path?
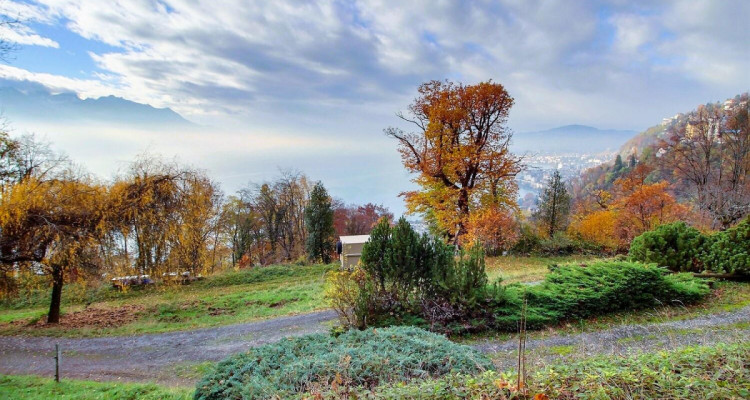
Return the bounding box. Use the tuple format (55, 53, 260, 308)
(0, 375, 193, 400)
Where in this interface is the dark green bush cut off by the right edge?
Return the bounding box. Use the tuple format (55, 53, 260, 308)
(702, 217, 750, 275)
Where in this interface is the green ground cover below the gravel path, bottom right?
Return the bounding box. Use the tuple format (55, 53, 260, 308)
(310, 342, 750, 400)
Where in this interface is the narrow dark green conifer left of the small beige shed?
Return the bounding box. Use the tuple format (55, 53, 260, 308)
(305, 182, 335, 264)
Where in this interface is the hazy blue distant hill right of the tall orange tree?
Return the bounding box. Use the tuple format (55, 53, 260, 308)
(511, 125, 636, 154)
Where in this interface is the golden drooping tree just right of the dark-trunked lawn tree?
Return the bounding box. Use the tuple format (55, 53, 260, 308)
(110, 157, 222, 275)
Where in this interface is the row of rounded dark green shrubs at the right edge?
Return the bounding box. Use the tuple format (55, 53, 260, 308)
(629, 217, 750, 275)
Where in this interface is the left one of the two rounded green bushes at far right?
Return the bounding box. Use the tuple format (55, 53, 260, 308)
(630, 222, 705, 272)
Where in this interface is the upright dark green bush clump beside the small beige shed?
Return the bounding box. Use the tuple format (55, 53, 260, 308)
(356, 218, 487, 328)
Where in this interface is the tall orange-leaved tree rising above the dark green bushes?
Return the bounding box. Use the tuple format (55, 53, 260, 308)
(385, 81, 521, 241)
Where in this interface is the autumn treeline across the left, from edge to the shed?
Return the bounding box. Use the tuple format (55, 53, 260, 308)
(0, 133, 390, 322)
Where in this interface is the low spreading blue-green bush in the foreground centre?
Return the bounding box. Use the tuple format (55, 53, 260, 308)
(195, 327, 492, 400)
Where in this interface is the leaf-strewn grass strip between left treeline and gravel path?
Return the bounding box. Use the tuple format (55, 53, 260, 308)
(0, 265, 333, 337)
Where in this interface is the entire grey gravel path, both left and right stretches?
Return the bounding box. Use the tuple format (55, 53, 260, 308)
(0, 306, 750, 386)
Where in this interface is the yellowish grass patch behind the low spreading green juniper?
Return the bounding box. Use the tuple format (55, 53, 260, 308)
(486, 255, 602, 283)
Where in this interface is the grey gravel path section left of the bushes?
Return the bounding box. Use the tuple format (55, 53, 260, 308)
(0, 310, 336, 386)
